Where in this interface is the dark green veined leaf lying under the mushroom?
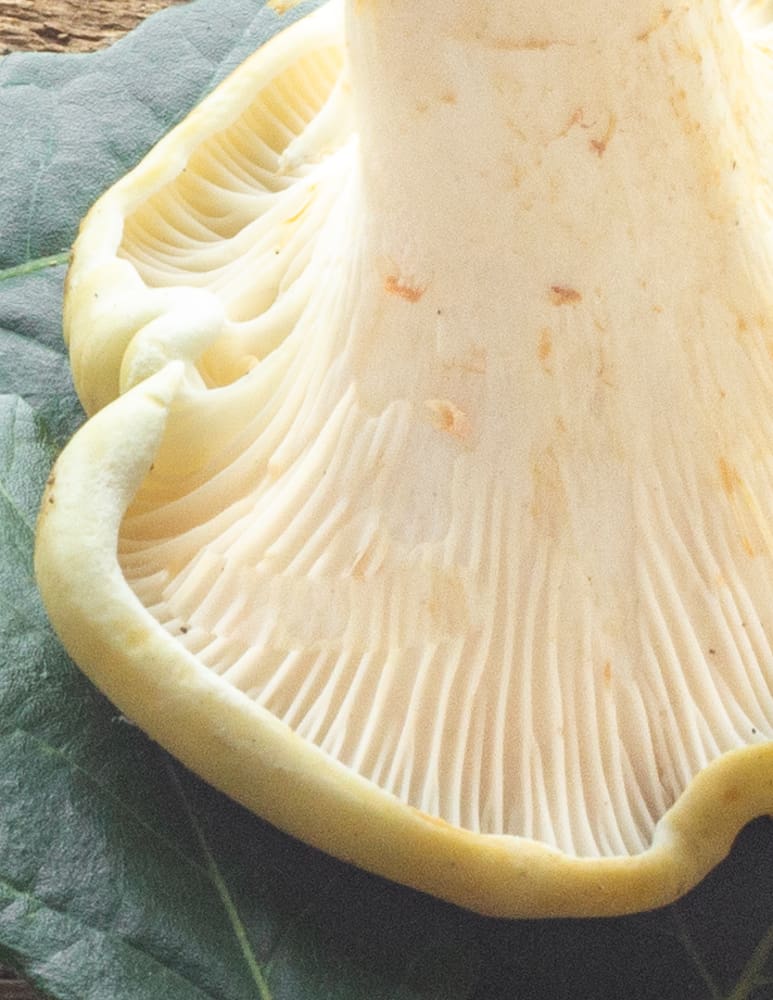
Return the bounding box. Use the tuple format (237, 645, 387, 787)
(0, 0, 773, 1000)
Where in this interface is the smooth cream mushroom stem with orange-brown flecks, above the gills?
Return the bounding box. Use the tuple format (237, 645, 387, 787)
(340, 0, 773, 460)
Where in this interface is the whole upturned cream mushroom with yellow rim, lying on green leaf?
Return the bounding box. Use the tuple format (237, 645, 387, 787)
(37, 0, 773, 915)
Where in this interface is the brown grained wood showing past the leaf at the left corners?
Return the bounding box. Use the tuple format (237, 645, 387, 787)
(0, 0, 185, 1000)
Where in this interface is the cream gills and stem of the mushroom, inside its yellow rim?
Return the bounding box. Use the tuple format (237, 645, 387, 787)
(101, 2, 773, 856)
